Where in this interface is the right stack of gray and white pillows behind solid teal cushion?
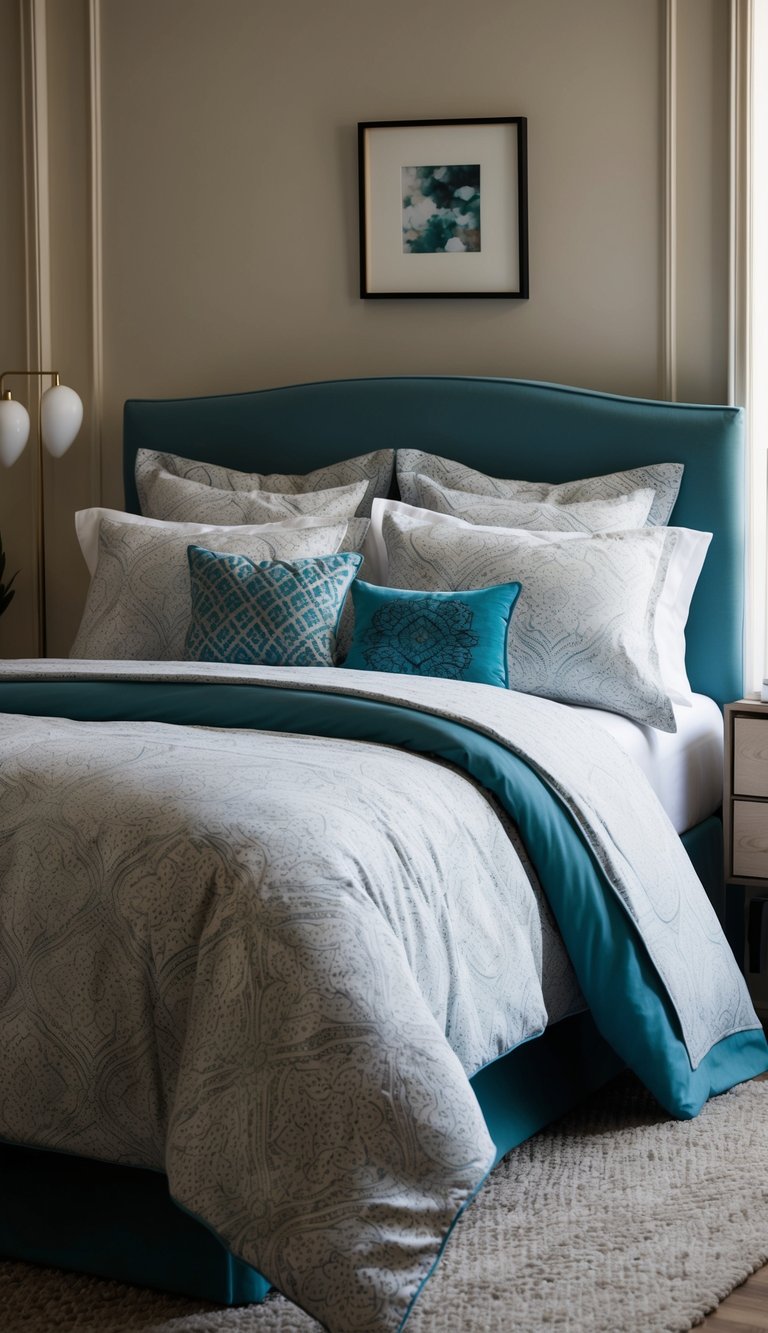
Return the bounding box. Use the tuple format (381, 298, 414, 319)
(362, 449, 711, 730)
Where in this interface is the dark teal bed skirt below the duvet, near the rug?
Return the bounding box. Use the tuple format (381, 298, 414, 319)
(0, 1013, 621, 1305)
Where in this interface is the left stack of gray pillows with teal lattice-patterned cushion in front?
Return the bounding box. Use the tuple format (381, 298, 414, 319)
(71, 449, 395, 667)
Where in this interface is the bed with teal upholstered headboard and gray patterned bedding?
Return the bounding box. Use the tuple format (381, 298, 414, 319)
(0, 377, 768, 1333)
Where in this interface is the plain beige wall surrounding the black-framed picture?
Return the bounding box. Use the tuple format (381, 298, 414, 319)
(0, 0, 728, 652)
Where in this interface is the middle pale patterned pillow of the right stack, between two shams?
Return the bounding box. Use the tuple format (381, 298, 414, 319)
(413, 473, 656, 532)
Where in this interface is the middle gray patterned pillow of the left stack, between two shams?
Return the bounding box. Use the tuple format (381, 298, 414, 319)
(141, 468, 368, 524)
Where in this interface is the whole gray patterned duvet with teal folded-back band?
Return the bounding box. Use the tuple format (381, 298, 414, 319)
(0, 661, 768, 1333)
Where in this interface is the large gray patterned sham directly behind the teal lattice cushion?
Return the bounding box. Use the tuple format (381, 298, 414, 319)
(69, 509, 368, 661)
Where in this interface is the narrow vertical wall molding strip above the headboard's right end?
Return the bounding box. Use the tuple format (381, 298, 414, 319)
(660, 0, 677, 401)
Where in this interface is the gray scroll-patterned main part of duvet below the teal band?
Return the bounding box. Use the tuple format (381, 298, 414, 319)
(0, 714, 579, 1333)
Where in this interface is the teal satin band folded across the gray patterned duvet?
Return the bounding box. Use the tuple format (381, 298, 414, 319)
(0, 681, 768, 1117)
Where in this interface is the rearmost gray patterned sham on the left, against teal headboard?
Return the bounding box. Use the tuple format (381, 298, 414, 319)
(135, 449, 395, 517)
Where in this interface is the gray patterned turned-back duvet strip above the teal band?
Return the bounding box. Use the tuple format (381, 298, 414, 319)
(0, 660, 760, 1069)
